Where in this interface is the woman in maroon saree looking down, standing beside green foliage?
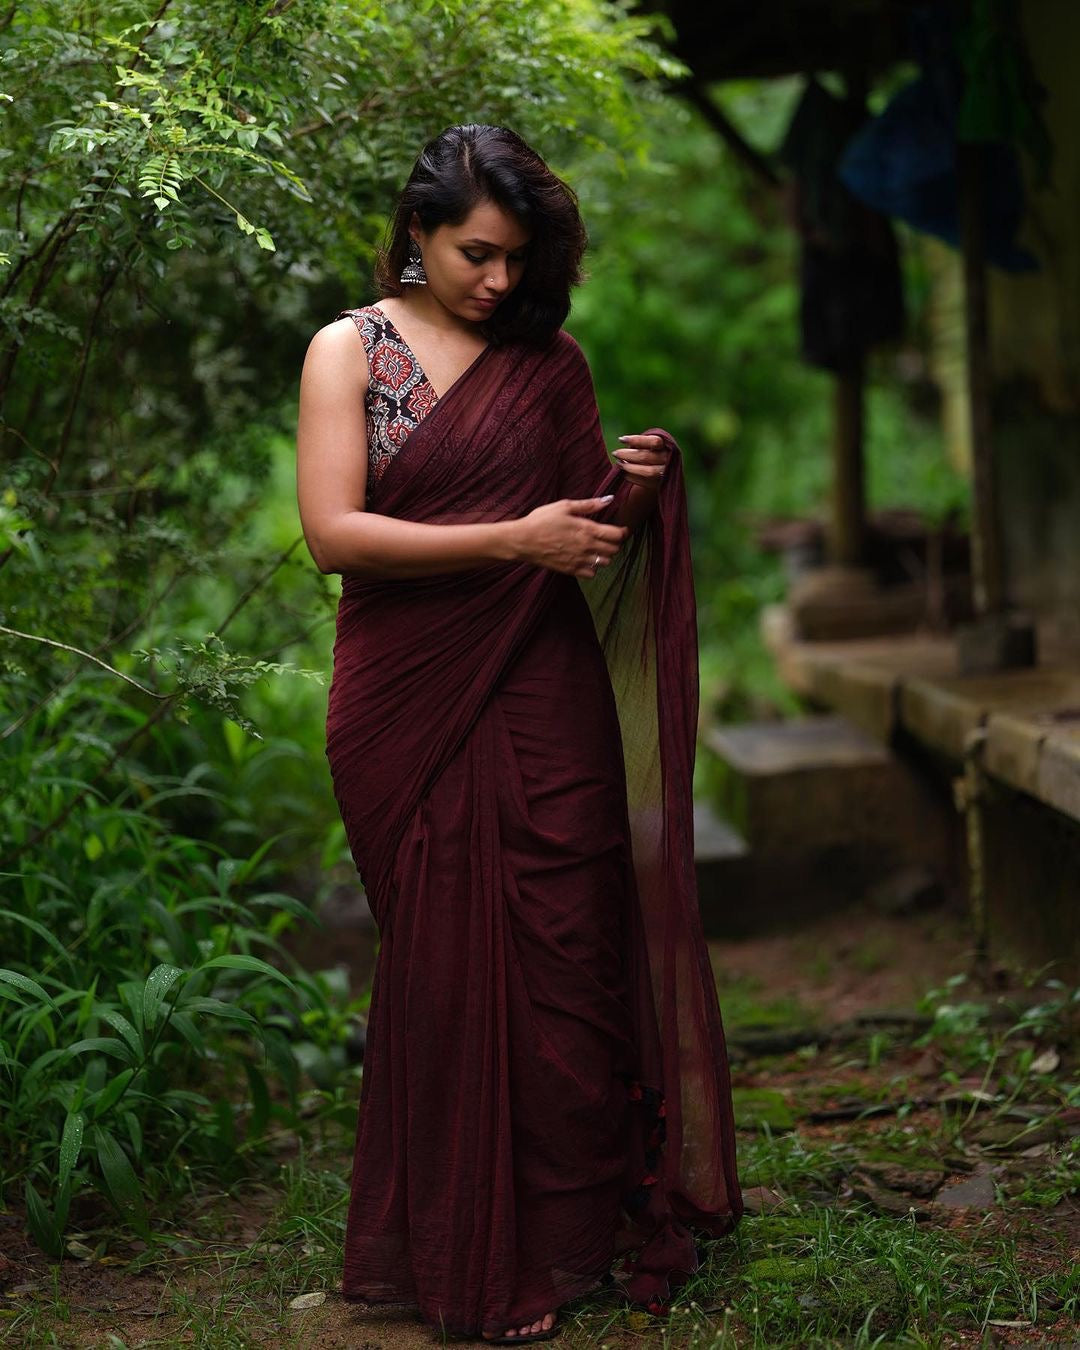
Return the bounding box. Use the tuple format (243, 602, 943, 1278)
(298, 126, 740, 1343)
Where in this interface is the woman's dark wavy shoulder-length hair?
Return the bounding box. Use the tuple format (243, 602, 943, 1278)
(375, 123, 587, 346)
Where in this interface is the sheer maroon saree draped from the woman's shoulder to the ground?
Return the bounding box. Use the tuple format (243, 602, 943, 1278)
(327, 332, 741, 1335)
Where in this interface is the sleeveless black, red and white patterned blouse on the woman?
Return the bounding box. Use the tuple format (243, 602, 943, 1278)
(335, 305, 439, 485)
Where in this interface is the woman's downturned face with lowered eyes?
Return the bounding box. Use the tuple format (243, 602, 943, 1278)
(409, 201, 531, 324)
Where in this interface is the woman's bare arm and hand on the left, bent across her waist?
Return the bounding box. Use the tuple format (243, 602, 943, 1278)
(297, 326, 628, 578)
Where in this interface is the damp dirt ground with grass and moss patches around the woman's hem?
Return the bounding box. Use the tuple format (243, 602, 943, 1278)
(0, 911, 1080, 1350)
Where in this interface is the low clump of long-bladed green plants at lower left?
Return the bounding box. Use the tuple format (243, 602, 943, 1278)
(0, 741, 363, 1256)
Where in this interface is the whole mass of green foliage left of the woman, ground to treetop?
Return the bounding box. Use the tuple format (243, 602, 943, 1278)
(0, 0, 676, 1254)
